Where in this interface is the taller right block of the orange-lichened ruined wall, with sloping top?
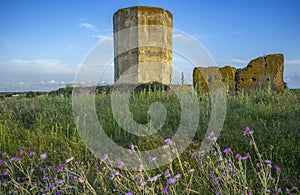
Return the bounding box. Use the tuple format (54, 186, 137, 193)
(236, 54, 284, 92)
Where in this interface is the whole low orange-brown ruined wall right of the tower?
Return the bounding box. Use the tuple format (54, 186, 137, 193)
(193, 54, 284, 92)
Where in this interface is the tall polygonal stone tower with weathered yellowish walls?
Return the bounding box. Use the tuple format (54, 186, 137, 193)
(113, 6, 173, 84)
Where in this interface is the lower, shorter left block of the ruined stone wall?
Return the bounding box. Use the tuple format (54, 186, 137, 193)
(193, 66, 236, 92)
